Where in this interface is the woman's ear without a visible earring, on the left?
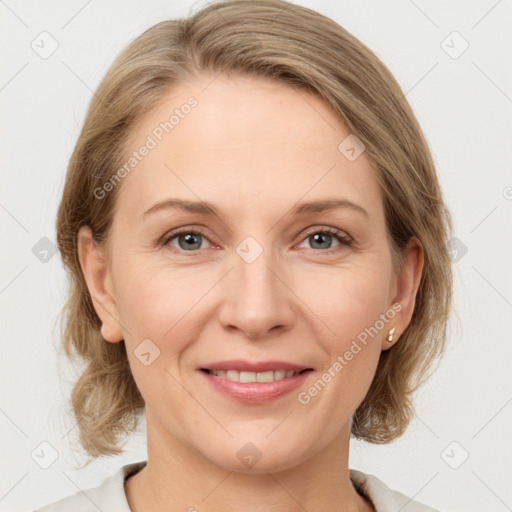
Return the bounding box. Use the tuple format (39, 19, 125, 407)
(78, 226, 123, 343)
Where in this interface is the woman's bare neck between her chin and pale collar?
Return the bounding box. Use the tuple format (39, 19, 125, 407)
(125, 414, 375, 512)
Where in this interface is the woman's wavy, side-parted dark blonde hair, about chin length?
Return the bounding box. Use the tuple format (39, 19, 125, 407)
(57, 0, 452, 459)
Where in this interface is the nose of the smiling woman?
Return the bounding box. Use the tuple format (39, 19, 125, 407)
(219, 251, 297, 339)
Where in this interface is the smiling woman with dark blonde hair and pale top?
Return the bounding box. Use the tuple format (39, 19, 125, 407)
(40, 0, 451, 512)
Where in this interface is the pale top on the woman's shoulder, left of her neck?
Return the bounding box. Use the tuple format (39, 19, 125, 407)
(34, 461, 146, 512)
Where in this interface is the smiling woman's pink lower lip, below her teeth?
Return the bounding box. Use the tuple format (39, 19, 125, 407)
(198, 370, 312, 404)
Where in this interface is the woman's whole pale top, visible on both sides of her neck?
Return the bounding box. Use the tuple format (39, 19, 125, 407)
(35, 461, 439, 512)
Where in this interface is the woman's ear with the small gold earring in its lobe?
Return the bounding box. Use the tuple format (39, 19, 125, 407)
(382, 237, 424, 350)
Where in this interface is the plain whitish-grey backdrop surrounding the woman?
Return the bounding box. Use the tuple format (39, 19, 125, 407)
(0, 0, 512, 512)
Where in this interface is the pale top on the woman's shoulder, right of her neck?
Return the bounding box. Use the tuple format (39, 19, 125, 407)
(349, 469, 439, 512)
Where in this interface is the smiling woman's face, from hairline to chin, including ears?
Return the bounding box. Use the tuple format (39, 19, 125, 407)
(81, 77, 420, 471)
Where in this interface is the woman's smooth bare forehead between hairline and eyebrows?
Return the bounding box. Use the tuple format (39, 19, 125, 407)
(118, 76, 380, 219)
